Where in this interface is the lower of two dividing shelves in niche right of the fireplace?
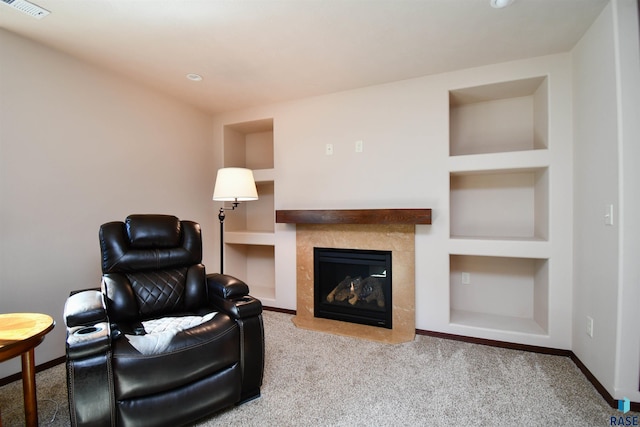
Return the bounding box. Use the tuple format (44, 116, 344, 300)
(449, 237, 551, 259)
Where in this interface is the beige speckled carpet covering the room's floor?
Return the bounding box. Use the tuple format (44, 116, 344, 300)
(0, 312, 637, 427)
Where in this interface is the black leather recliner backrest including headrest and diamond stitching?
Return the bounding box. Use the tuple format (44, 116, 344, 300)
(100, 215, 207, 322)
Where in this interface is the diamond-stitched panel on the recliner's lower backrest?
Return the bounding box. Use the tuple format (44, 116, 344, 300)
(127, 267, 187, 315)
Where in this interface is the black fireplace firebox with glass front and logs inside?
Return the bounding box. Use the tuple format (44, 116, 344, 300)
(313, 248, 392, 329)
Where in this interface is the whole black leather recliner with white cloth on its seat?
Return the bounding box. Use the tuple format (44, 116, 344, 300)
(64, 215, 264, 427)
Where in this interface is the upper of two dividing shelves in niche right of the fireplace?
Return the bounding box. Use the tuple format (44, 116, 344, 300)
(449, 149, 549, 175)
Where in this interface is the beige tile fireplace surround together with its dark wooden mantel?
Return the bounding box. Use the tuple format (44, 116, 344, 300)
(276, 209, 431, 344)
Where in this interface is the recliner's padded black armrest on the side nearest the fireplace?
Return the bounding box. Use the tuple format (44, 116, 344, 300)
(207, 273, 262, 319)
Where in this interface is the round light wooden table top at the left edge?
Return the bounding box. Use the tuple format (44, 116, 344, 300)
(0, 313, 55, 361)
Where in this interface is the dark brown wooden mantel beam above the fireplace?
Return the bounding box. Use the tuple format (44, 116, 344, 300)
(276, 209, 431, 224)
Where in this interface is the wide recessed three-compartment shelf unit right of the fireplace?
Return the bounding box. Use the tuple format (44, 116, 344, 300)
(449, 76, 551, 339)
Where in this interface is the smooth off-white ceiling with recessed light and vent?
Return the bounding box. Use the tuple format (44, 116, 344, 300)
(0, 0, 609, 113)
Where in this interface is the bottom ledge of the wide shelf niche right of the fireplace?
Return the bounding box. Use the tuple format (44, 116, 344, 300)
(449, 310, 548, 335)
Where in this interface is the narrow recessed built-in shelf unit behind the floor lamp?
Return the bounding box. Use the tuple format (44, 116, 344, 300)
(223, 119, 275, 302)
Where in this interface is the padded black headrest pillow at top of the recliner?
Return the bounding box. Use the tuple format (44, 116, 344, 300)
(125, 215, 180, 249)
